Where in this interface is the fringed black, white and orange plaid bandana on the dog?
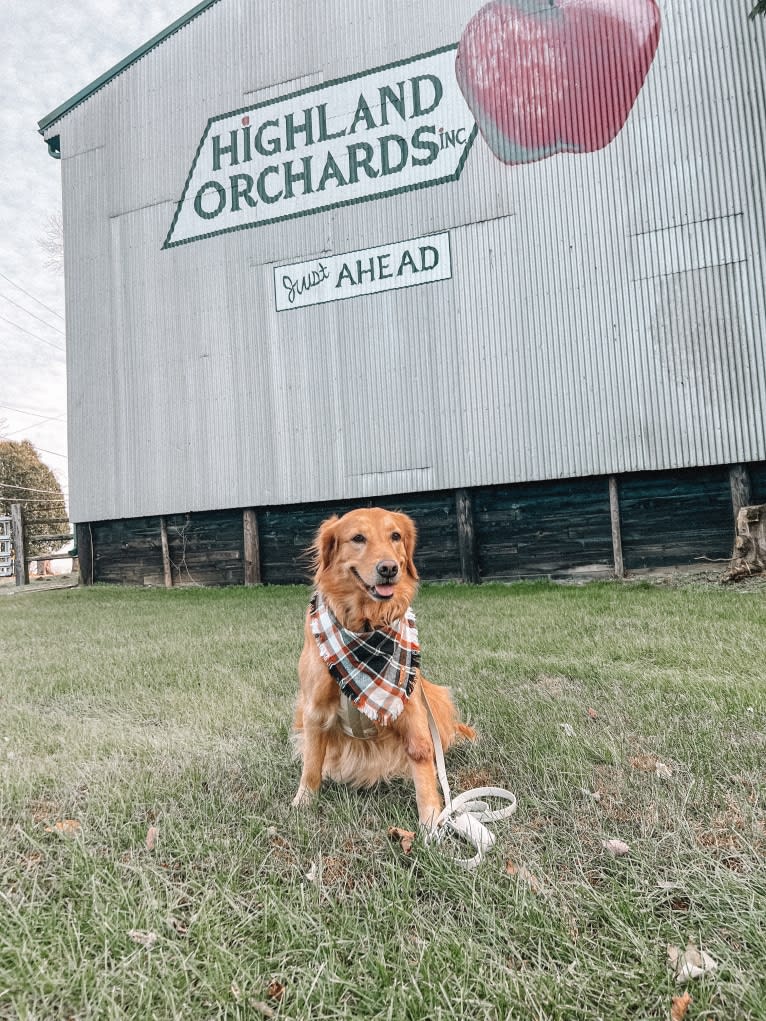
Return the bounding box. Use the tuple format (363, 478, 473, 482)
(308, 592, 420, 727)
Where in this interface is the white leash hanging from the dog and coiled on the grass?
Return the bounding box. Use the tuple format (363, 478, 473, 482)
(421, 687, 516, 869)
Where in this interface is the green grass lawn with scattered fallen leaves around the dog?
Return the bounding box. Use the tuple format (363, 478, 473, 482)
(0, 583, 766, 1021)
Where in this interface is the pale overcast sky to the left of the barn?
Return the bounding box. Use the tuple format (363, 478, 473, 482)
(0, 0, 195, 510)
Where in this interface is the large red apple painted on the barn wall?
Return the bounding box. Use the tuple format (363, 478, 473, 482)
(456, 0, 660, 163)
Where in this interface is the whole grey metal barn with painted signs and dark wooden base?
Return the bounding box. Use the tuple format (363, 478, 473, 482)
(40, 0, 766, 584)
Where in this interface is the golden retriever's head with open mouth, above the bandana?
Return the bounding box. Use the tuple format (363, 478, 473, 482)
(314, 507, 418, 630)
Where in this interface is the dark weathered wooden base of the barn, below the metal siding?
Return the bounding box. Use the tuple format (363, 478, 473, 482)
(77, 461, 766, 585)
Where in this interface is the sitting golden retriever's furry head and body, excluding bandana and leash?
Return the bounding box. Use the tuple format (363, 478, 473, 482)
(292, 507, 476, 828)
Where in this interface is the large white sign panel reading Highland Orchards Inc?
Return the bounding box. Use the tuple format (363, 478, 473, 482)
(163, 46, 477, 248)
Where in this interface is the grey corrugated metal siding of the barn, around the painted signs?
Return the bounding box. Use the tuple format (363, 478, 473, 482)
(49, 0, 766, 521)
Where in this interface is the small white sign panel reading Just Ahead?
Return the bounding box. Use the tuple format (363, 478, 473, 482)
(274, 233, 452, 312)
